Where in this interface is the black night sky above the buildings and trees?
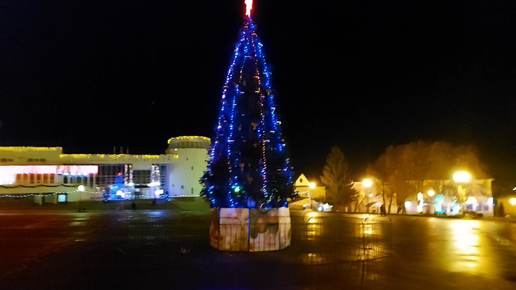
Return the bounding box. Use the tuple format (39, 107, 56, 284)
(0, 0, 516, 178)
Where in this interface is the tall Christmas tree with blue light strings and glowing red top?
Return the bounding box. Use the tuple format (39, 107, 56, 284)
(201, 0, 293, 208)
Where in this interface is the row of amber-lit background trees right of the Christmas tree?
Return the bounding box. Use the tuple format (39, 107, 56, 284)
(320, 140, 489, 210)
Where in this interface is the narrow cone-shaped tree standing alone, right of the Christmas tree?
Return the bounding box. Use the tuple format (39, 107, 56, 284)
(320, 146, 358, 206)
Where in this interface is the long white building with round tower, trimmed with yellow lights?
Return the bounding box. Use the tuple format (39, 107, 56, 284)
(0, 136, 210, 203)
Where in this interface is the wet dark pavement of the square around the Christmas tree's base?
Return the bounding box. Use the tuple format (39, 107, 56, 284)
(0, 211, 516, 290)
